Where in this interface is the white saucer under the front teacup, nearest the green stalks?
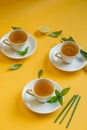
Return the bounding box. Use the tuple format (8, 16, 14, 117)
(22, 79, 62, 114)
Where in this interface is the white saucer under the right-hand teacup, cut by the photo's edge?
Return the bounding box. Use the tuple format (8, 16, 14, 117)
(49, 43, 87, 72)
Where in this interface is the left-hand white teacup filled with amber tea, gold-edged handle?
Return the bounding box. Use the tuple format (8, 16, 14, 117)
(3, 29, 29, 50)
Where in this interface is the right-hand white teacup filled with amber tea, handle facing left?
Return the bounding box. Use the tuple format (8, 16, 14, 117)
(57, 41, 80, 63)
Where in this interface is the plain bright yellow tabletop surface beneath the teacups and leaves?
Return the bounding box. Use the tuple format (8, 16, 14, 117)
(0, 0, 87, 130)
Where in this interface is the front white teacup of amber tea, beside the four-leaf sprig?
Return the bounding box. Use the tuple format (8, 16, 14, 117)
(26, 78, 54, 103)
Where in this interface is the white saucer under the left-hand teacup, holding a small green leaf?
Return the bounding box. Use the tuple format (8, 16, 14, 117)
(0, 34, 37, 59)
